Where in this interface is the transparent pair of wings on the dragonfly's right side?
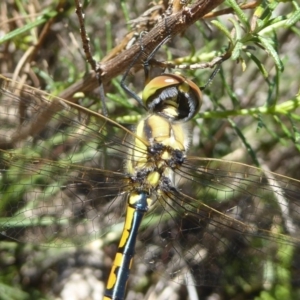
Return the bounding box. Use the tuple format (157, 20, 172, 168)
(135, 157, 300, 289)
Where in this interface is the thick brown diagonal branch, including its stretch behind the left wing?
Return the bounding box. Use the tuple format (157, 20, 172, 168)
(0, 0, 224, 149)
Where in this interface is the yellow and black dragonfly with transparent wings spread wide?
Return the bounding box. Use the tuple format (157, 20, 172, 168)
(0, 74, 300, 300)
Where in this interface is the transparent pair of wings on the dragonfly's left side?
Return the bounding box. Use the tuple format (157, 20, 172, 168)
(0, 78, 138, 246)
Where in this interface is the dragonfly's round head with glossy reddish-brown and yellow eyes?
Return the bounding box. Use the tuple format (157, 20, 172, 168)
(142, 74, 202, 122)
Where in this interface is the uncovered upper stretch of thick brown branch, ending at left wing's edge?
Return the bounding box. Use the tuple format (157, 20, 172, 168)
(59, 0, 224, 101)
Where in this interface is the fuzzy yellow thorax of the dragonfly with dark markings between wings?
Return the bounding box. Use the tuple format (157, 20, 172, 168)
(127, 114, 189, 193)
